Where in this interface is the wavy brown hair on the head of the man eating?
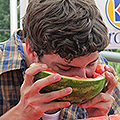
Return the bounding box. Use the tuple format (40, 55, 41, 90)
(23, 0, 109, 61)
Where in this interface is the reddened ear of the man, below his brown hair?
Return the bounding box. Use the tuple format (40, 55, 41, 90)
(26, 38, 38, 63)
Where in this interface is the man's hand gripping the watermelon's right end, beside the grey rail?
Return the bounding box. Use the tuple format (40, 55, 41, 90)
(78, 65, 117, 117)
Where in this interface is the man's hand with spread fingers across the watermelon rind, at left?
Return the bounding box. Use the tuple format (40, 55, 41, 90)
(17, 64, 72, 120)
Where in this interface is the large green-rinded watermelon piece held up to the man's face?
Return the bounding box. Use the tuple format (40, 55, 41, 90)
(31, 65, 106, 104)
